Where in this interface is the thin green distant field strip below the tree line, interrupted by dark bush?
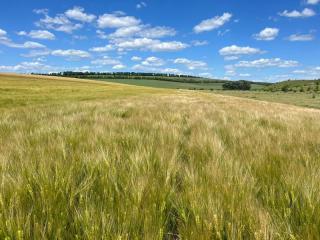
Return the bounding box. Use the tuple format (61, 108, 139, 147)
(84, 79, 264, 90)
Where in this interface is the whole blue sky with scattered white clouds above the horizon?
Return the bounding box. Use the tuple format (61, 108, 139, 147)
(0, 0, 320, 82)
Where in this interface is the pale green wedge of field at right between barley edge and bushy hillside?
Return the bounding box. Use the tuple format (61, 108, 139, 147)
(216, 91, 320, 109)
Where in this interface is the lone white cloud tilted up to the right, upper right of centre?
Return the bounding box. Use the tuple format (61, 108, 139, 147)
(193, 13, 232, 33)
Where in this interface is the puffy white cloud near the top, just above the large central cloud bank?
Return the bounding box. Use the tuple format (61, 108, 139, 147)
(97, 12, 141, 28)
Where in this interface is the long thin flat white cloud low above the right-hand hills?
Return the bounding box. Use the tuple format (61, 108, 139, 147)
(234, 58, 299, 68)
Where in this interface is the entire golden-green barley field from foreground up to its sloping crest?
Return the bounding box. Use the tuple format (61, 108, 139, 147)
(0, 76, 320, 239)
